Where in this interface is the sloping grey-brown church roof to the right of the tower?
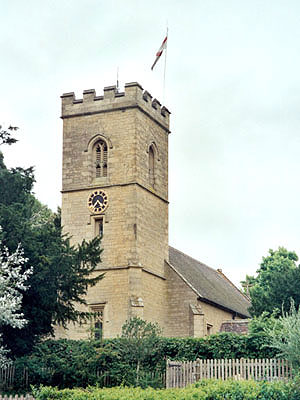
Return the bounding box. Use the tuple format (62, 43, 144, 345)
(169, 246, 250, 317)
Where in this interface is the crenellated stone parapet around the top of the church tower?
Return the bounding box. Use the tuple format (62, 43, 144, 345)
(61, 82, 170, 130)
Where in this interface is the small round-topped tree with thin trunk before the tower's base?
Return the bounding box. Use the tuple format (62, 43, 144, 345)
(121, 317, 161, 386)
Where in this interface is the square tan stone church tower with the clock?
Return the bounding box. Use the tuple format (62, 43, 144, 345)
(57, 82, 170, 339)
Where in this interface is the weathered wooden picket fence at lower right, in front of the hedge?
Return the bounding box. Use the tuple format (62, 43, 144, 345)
(166, 358, 292, 388)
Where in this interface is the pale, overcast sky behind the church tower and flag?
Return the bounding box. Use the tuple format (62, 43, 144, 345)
(0, 0, 300, 284)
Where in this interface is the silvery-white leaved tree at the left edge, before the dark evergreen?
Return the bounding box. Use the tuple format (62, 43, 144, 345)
(0, 233, 32, 367)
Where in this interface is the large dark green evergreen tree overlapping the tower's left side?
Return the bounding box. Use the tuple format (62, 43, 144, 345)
(0, 142, 103, 356)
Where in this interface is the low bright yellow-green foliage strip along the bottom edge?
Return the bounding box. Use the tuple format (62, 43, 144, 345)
(33, 380, 300, 400)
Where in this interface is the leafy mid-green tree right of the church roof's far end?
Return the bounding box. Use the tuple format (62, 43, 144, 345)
(247, 247, 300, 316)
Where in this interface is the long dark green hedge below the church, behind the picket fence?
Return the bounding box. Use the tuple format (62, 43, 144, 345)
(10, 333, 276, 388)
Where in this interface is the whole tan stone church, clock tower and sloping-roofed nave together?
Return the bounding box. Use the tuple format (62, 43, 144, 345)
(56, 82, 250, 339)
